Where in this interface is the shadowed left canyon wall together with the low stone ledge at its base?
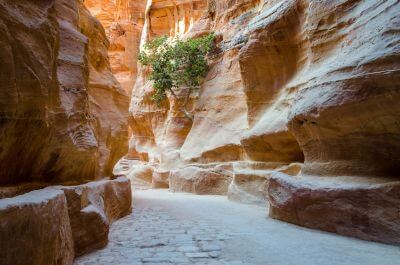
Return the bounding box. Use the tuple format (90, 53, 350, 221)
(0, 0, 132, 265)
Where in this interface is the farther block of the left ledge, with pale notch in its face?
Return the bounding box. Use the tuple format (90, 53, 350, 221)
(60, 177, 132, 256)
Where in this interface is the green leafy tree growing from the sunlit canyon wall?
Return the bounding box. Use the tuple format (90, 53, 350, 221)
(139, 34, 214, 107)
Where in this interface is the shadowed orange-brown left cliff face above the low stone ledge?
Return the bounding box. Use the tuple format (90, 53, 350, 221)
(0, 0, 128, 185)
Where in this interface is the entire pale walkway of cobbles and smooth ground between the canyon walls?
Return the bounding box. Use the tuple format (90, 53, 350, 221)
(75, 190, 400, 265)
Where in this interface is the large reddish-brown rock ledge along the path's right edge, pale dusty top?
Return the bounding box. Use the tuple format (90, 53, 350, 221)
(268, 173, 400, 245)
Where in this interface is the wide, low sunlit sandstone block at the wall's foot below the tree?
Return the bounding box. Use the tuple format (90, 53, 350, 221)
(169, 165, 232, 195)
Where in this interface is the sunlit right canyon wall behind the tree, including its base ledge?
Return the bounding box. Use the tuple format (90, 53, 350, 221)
(121, 0, 400, 244)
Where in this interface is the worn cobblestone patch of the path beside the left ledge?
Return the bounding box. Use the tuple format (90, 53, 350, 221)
(75, 203, 248, 265)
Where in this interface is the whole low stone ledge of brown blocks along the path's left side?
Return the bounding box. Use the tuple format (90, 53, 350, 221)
(0, 174, 132, 265)
